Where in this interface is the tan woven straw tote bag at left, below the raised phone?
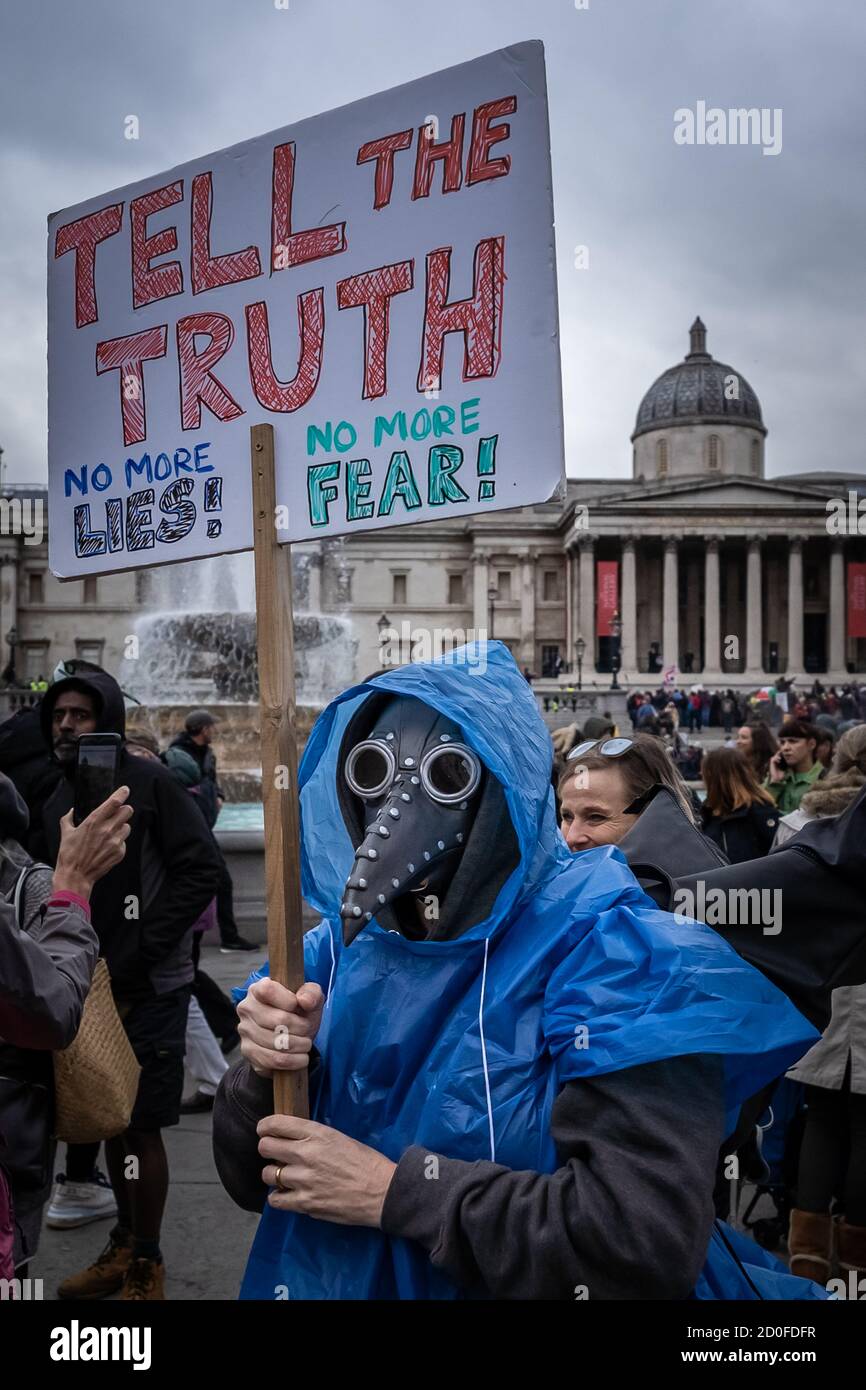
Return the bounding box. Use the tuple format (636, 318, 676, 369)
(54, 956, 142, 1144)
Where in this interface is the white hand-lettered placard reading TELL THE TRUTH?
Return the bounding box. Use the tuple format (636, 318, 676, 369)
(49, 42, 563, 577)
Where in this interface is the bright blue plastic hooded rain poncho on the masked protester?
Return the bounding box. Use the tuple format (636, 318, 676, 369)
(242, 642, 816, 1300)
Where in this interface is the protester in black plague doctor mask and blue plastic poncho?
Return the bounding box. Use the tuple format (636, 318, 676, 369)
(214, 644, 820, 1300)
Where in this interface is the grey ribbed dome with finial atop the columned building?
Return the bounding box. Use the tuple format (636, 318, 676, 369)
(631, 318, 767, 441)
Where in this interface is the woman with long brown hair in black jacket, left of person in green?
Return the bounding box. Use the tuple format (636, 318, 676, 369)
(701, 748, 778, 865)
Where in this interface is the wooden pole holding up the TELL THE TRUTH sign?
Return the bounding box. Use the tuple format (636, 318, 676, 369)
(250, 425, 309, 1119)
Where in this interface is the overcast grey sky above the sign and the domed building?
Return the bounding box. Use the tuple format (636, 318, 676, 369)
(0, 0, 866, 482)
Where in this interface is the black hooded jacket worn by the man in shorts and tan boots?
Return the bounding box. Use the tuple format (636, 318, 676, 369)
(40, 671, 220, 1001)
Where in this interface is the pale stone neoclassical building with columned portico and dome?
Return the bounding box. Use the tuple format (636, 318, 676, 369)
(0, 318, 866, 688)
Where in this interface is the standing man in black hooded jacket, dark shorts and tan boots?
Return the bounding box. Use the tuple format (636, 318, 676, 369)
(40, 671, 220, 1301)
